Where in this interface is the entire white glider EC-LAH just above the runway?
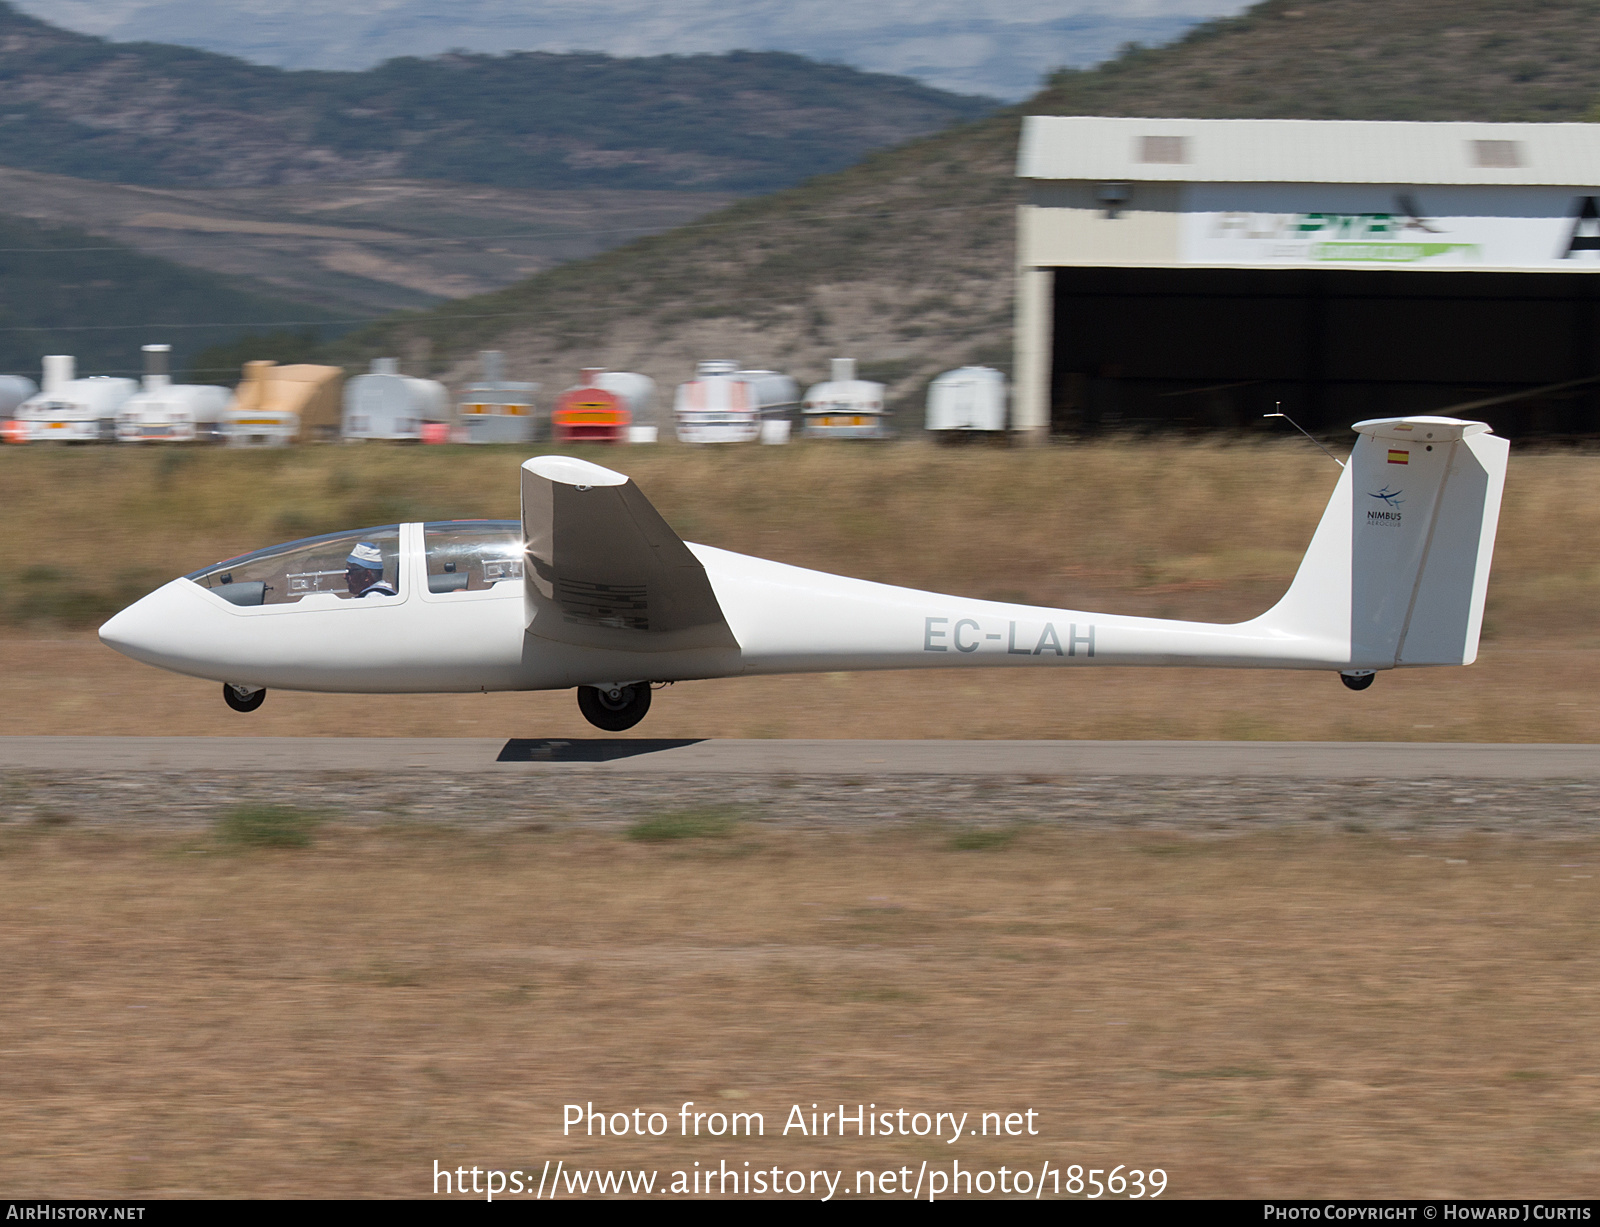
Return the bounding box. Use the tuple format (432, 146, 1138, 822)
(99, 418, 1507, 731)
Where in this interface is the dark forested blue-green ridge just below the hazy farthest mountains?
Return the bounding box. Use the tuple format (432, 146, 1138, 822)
(0, 3, 997, 192)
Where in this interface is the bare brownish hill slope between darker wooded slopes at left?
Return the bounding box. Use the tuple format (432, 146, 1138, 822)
(0, 166, 736, 320)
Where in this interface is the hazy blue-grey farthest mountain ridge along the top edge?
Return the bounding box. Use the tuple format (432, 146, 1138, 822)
(12, 0, 1243, 101)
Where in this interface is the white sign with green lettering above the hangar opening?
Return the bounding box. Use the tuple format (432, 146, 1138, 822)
(1181, 184, 1600, 270)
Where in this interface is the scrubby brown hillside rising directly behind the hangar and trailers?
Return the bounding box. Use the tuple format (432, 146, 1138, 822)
(324, 0, 1600, 406)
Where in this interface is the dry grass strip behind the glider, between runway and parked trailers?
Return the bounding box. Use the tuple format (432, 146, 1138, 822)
(0, 440, 1600, 741)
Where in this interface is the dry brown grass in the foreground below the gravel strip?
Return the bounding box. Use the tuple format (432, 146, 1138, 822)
(0, 816, 1600, 1198)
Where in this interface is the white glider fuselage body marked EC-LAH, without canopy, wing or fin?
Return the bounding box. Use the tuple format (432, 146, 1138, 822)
(101, 540, 1350, 694)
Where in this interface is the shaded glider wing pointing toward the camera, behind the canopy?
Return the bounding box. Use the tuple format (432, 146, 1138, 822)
(522, 456, 738, 651)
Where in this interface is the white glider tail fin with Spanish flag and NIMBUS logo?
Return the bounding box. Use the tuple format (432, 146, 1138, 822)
(1261, 418, 1509, 669)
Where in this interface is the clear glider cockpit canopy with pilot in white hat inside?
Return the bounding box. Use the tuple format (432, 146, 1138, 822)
(186, 520, 523, 606)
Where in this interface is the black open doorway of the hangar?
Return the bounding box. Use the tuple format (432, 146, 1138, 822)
(1050, 269, 1600, 438)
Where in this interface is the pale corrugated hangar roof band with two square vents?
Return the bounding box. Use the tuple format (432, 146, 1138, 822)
(1016, 115, 1600, 187)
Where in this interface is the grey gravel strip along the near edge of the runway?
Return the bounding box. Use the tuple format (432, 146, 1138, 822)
(0, 769, 1600, 838)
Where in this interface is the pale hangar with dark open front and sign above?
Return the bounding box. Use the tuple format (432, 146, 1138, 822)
(1013, 115, 1600, 438)
